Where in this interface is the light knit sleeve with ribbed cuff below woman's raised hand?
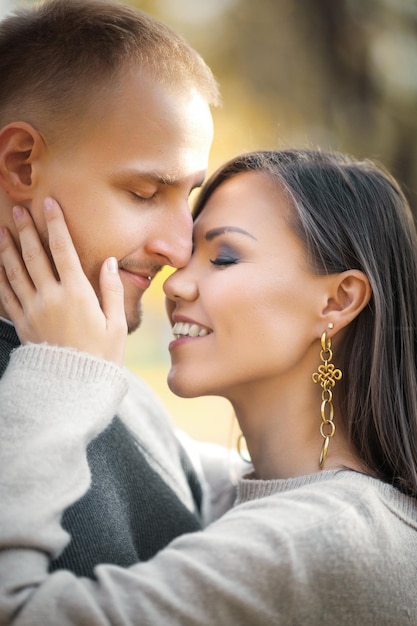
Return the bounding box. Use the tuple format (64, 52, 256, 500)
(0, 344, 127, 556)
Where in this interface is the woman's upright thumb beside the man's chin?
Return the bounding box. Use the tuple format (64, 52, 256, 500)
(100, 257, 127, 364)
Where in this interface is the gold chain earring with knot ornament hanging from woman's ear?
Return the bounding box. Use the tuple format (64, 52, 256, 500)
(312, 322, 342, 469)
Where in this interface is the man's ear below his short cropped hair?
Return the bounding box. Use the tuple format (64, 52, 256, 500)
(0, 122, 44, 202)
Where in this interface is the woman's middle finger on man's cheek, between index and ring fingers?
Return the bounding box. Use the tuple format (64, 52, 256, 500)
(11, 206, 55, 286)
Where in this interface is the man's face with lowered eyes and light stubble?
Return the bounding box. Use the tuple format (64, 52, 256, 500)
(32, 75, 213, 332)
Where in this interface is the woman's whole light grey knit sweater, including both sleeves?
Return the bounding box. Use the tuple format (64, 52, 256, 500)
(0, 346, 417, 626)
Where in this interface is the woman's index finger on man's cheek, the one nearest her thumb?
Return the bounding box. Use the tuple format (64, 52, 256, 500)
(44, 198, 86, 282)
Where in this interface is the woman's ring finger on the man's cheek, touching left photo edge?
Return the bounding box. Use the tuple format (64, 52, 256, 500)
(0, 222, 35, 306)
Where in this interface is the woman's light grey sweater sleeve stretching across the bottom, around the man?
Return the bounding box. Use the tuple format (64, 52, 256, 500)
(0, 476, 417, 626)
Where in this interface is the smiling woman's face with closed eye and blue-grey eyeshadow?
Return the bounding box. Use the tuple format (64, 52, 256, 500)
(164, 172, 325, 400)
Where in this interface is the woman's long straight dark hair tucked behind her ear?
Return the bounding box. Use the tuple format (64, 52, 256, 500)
(194, 150, 417, 496)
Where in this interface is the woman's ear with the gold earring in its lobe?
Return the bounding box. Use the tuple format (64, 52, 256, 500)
(322, 270, 372, 330)
